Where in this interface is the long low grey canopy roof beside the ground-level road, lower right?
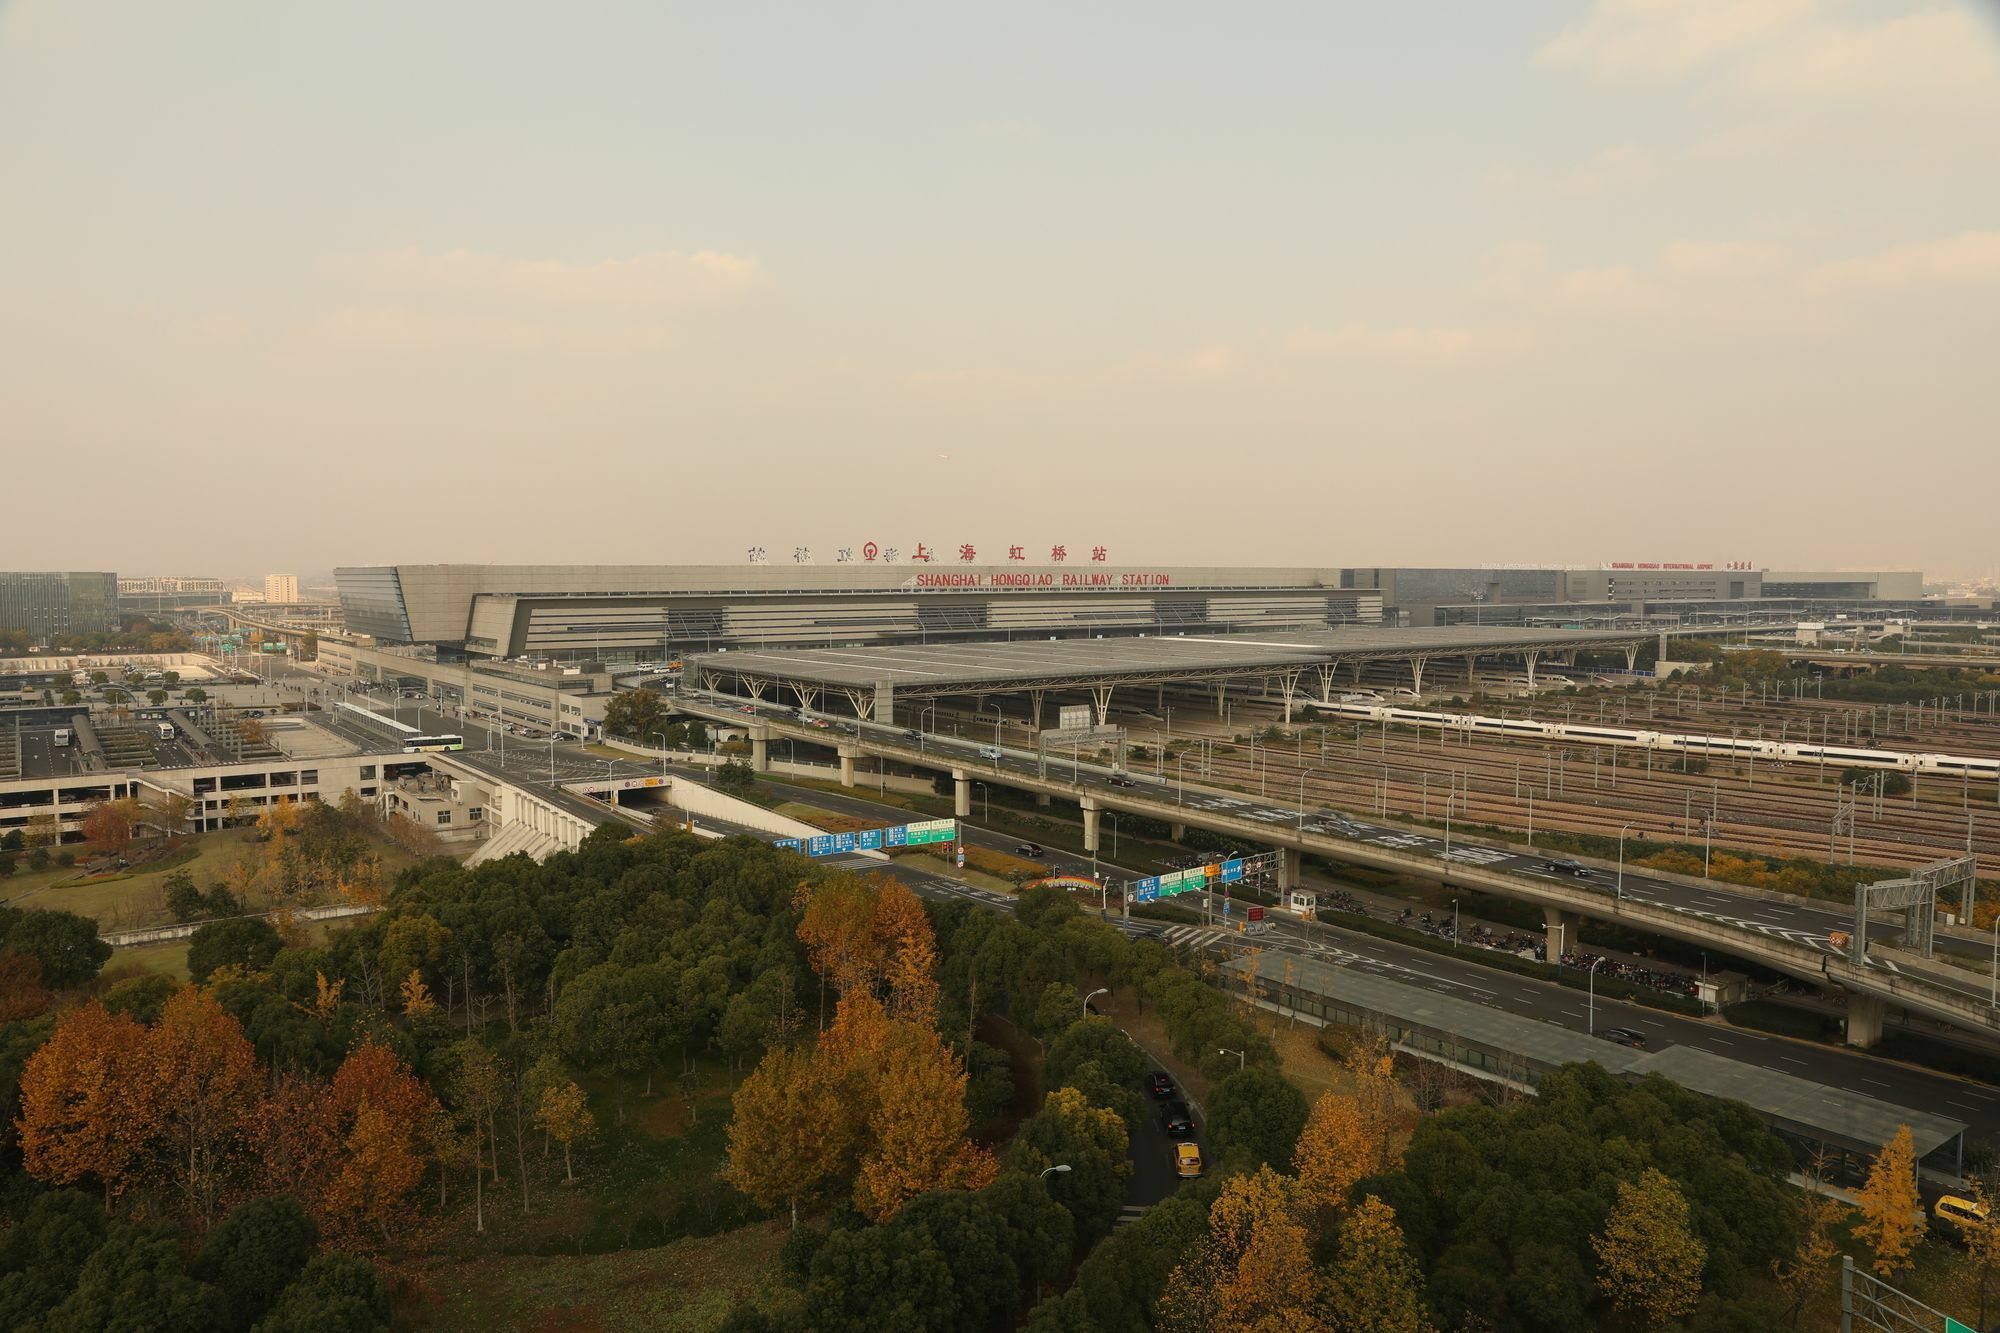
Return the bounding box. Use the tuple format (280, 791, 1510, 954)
(1230, 953, 1966, 1157)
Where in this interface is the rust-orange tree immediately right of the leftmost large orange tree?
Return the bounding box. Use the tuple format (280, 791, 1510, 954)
(142, 987, 264, 1225)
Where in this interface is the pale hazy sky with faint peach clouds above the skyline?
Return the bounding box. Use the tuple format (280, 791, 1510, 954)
(0, 0, 2000, 572)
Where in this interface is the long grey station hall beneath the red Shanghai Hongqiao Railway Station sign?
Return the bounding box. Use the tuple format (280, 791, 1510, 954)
(334, 560, 1382, 662)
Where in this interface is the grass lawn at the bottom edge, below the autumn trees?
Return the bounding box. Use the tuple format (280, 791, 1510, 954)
(412, 1221, 786, 1333)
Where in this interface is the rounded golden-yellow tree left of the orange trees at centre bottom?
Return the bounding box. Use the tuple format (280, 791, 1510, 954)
(722, 1047, 860, 1227)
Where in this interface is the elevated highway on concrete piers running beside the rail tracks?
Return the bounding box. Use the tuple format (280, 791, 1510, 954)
(672, 695, 2000, 1047)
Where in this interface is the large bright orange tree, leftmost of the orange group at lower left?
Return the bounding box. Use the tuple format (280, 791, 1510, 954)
(20, 1001, 152, 1203)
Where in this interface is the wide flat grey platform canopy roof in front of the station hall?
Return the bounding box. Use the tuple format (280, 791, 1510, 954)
(688, 624, 1652, 697)
